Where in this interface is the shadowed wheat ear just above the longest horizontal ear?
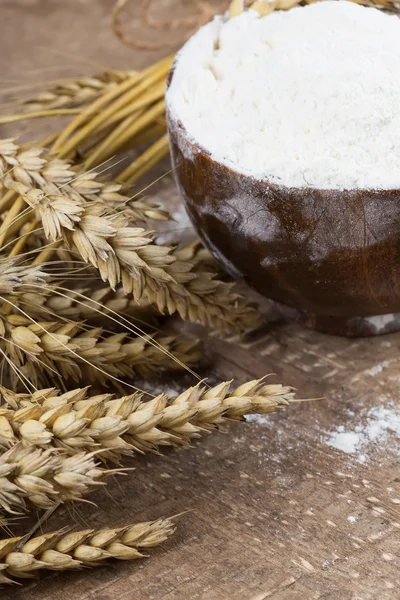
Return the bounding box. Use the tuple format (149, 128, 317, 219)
(0, 315, 202, 386)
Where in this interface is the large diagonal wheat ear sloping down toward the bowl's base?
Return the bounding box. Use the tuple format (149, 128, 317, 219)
(0, 140, 260, 331)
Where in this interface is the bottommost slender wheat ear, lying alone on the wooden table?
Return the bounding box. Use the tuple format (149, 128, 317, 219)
(0, 519, 175, 584)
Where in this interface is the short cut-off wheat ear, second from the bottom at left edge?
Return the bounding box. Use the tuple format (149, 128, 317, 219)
(0, 444, 115, 513)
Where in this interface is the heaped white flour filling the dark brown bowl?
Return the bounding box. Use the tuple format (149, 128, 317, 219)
(167, 1, 400, 189)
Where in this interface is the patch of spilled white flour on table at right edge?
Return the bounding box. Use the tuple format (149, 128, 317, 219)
(323, 405, 400, 463)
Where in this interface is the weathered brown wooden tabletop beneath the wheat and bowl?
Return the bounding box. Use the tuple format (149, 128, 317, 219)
(0, 0, 400, 600)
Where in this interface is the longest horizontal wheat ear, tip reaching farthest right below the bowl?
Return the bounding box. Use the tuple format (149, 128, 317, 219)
(0, 380, 296, 462)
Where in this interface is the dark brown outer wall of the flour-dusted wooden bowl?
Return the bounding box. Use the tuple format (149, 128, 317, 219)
(168, 102, 400, 332)
